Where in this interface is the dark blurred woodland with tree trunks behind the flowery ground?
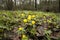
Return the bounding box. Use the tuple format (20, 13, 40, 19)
(0, 0, 60, 12)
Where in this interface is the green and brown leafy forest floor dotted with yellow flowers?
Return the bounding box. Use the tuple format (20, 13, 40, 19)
(0, 11, 60, 40)
